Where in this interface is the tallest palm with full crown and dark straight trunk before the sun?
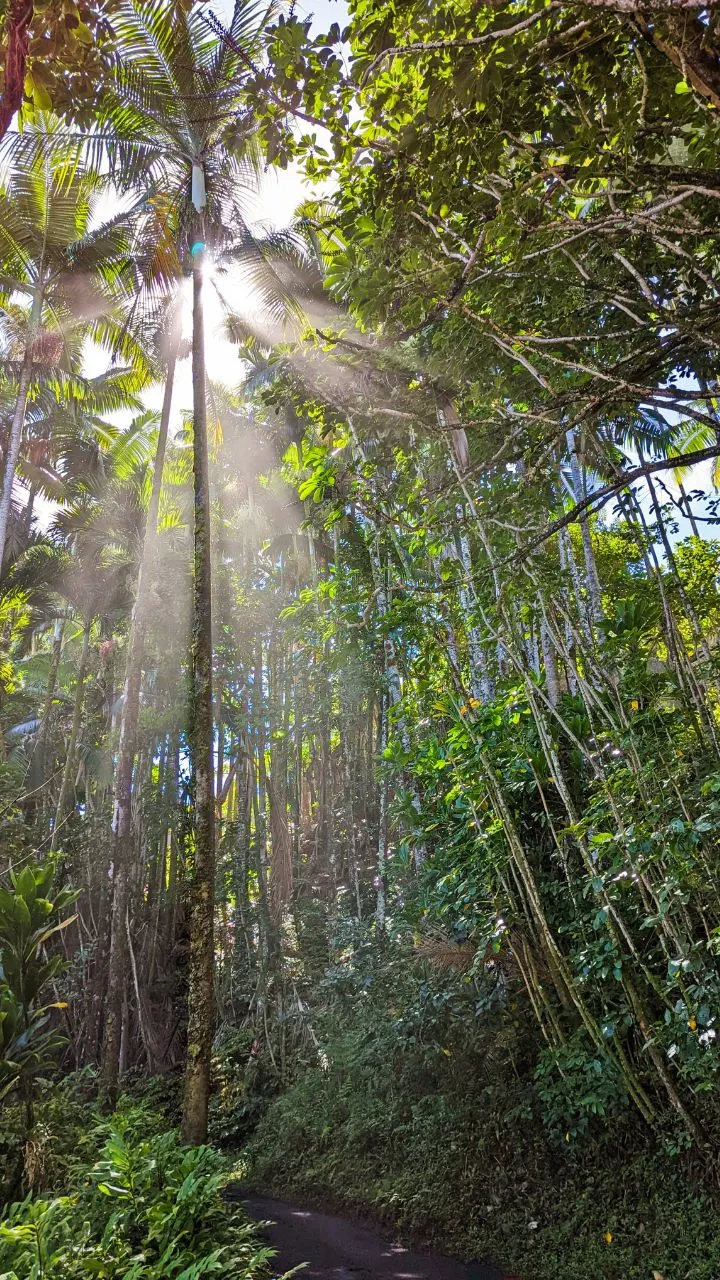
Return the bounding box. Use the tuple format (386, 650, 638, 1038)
(90, 0, 303, 1143)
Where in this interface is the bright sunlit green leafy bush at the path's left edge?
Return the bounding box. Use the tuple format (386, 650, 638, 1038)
(0, 1111, 272, 1280)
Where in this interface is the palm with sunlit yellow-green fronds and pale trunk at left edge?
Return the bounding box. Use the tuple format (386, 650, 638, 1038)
(0, 132, 146, 562)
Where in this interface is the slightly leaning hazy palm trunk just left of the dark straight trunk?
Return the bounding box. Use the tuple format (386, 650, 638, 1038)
(100, 345, 178, 1108)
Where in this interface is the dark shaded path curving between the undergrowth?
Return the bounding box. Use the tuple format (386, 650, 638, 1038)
(243, 1196, 512, 1280)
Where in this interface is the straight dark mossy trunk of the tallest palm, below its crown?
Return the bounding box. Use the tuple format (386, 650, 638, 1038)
(181, 252, 215, 1146)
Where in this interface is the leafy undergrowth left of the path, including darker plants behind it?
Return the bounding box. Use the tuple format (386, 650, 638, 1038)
(0, 1082, 272, 1280)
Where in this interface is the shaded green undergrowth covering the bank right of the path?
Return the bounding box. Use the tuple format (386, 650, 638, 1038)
(234, 931, 720, 1280)
